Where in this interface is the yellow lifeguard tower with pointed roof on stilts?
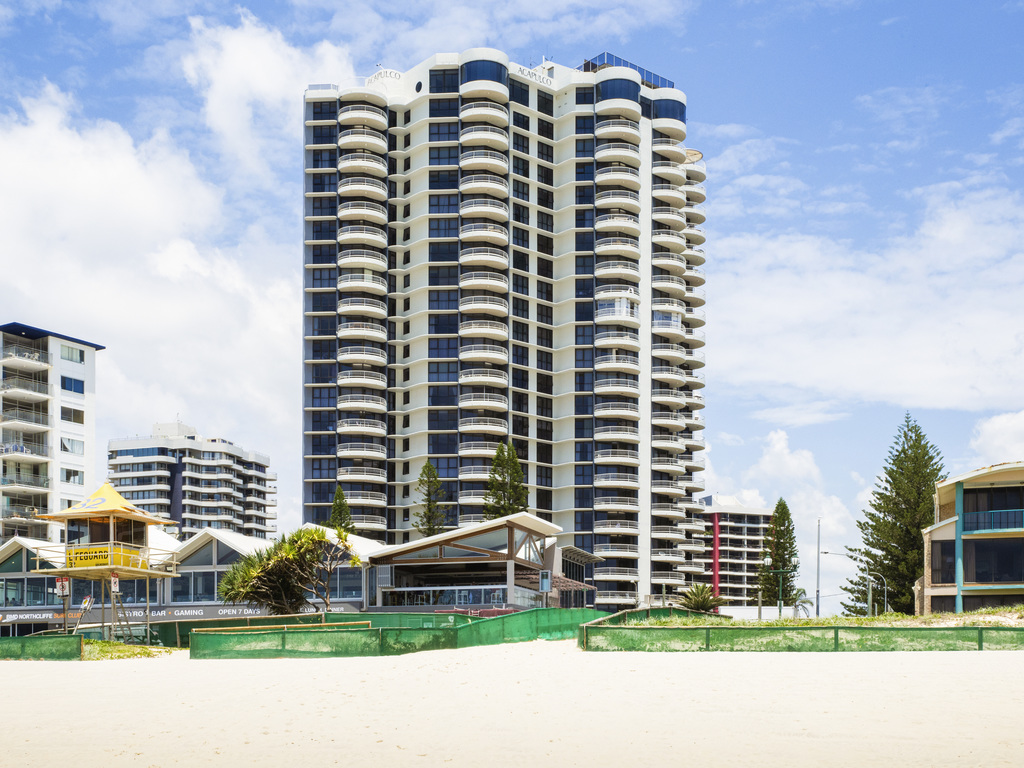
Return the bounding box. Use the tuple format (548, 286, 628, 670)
(33, 482, 177, 639)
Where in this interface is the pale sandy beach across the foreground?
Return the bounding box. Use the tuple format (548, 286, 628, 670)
(8, 641, 1024, 768)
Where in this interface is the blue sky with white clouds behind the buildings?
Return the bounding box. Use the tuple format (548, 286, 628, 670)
(0, 0, 1024, 612)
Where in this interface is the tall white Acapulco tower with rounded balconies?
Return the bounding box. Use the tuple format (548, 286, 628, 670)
(302, 48, 707, 608)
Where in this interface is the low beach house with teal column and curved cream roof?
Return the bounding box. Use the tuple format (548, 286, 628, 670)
(918, 462, 1024, 613)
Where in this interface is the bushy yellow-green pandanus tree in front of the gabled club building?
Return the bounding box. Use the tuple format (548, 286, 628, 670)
(217, 527, 359, 614)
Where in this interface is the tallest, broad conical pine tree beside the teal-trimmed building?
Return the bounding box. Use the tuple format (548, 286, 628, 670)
(843, 414, 945, 615)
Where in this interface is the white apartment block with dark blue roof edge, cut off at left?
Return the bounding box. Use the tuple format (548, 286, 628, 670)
(0, 323, 103, 543)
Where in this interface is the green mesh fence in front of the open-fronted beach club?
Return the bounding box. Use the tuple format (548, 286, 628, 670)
(189, 608, 606, 658)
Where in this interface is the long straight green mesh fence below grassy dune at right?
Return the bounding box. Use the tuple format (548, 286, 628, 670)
(579, 620, 1024, 652)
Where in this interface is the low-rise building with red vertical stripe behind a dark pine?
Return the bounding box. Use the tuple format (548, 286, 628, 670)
(693, 494, 773, 605)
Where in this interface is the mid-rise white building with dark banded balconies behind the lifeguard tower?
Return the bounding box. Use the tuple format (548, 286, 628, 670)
(106, 422, 278, 539)
